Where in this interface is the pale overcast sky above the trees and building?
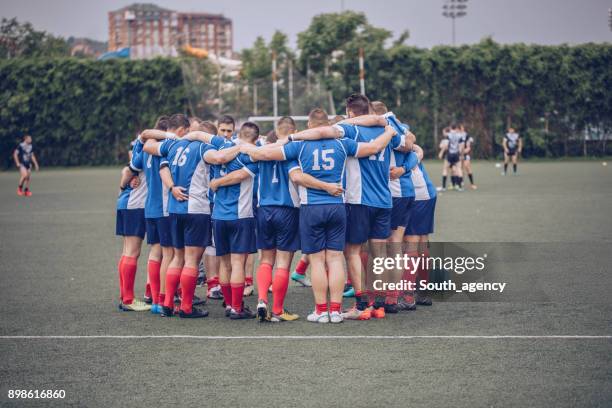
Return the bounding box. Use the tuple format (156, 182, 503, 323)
(0, 0, 612, 51)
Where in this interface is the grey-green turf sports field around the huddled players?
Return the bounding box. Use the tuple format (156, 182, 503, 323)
(0, 161, 612, 407)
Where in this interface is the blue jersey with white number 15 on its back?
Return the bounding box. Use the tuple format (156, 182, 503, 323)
(283, 138, 359, 204)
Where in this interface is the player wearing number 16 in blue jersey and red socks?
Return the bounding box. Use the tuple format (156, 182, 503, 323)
(142, 114, 238, 318)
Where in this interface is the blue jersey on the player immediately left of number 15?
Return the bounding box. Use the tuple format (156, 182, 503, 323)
(257, 160, 300, 207)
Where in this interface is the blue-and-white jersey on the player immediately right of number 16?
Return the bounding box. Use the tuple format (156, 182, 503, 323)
(212, 151, 258, 221)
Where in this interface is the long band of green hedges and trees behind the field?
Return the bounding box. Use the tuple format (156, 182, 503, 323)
(0, 12, 612, 166)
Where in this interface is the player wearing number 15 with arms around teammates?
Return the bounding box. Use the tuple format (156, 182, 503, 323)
(245, 107, 396, 323)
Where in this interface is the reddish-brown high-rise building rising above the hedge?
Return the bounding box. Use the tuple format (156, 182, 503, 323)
(108, 3, 233, 58)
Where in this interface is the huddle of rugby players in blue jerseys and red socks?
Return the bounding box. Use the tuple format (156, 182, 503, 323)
(116, 94, 436, 323)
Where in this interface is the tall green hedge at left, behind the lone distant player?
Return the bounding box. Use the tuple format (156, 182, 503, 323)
(0, 58, 186, 167)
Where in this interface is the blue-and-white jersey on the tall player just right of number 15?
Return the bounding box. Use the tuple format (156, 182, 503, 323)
(334, 124, 404, 208)
